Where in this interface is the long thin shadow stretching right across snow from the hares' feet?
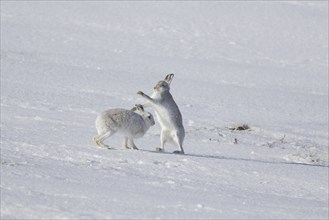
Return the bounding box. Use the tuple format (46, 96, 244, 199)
(140, 150, 329, 167)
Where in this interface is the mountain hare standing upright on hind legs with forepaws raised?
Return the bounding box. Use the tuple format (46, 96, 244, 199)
(137, 74, 185, 154)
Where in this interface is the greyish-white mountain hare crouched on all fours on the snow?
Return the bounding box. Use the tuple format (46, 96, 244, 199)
(94, 105, 155, 150)
